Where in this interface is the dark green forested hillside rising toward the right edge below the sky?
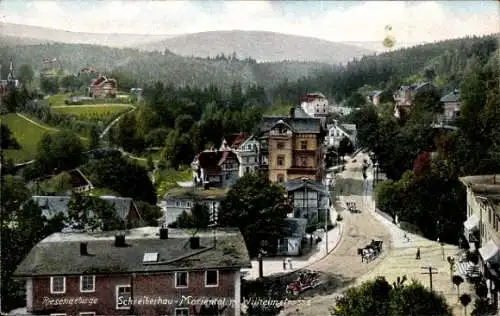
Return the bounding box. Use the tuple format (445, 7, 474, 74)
(274, 34, 500, 102)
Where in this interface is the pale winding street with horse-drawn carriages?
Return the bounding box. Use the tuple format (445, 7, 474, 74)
(280, 154, 391, 316)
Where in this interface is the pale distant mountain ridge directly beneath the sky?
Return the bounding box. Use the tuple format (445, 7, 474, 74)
(0, 23, 375, 64)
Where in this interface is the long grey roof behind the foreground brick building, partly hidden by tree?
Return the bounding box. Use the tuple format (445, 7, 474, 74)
(31, 195, 133, 220)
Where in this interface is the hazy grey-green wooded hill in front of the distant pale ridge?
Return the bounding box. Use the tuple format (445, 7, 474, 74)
(0, 43, 331, 87)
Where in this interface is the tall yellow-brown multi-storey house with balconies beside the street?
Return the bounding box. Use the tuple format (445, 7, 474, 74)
(259, 107, 326, 183)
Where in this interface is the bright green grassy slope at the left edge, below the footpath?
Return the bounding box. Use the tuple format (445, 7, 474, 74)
(0, 113, 55, 163)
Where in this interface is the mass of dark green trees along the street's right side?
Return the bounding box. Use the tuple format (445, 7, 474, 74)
(347, 41, 500, 244)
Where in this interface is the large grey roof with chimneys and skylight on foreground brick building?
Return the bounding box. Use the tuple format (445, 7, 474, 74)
(15, 227, 251, 276)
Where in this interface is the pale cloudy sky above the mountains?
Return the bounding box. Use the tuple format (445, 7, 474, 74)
(0, 0, 500, 42)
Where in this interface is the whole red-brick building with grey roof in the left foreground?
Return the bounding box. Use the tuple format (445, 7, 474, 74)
(15, 227, 251, 316)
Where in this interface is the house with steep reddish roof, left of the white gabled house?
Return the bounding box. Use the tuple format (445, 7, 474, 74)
(191, 149, 240, 188)
